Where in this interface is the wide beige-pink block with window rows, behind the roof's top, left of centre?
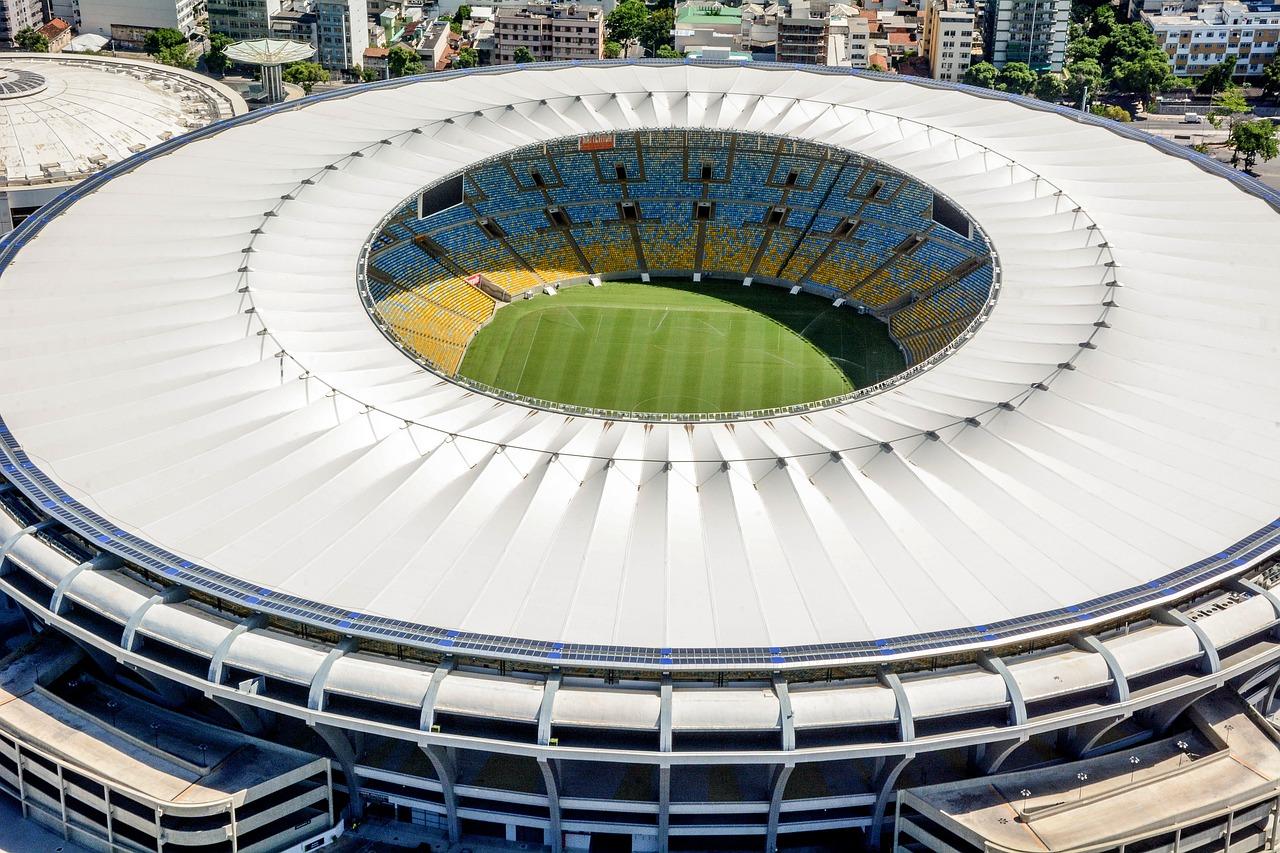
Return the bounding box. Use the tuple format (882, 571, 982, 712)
(494, 3, 604, 65)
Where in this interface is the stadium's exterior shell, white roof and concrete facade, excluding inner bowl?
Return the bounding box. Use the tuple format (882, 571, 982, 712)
(0, 63, 1280, 850)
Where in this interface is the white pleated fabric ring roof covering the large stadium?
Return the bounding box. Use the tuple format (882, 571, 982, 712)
(0, 64, 1280, 648)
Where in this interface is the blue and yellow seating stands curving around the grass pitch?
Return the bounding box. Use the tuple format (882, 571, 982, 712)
(367, 129, 992, 375)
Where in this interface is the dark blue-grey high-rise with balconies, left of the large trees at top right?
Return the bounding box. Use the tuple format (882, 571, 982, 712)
(983, 0, 1071, 72)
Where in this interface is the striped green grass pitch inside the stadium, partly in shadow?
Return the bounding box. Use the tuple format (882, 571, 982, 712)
(458, 282, 904, 414)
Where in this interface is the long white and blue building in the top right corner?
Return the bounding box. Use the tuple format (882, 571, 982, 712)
(1142, 0, 1280, 77)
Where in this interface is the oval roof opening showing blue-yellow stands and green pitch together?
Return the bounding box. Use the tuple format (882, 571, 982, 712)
(360, 129, 996, 420)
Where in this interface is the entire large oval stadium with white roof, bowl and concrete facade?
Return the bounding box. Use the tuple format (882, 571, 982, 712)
(0, 61, 1280, 853)
